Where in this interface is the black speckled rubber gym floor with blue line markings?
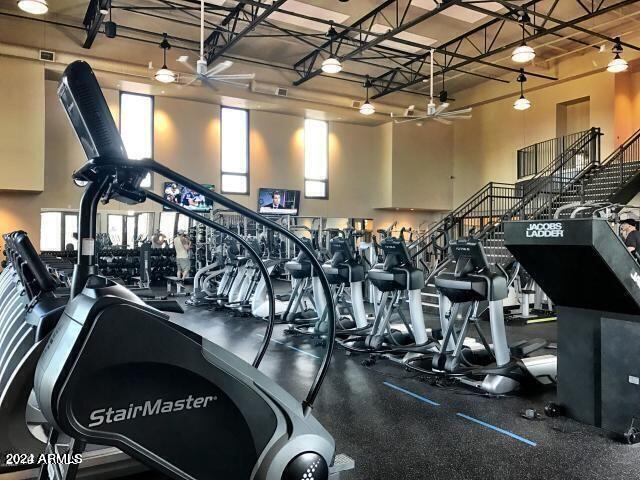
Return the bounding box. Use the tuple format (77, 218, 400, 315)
(126, 300, 640, 480)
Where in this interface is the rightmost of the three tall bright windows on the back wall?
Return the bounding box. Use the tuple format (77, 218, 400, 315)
(304, 119, 329, 198)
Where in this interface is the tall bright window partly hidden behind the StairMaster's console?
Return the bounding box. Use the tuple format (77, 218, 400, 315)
(120, 92, 153, 188)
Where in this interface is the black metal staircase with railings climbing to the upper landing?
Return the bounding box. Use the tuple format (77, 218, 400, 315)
(413, 128, 640, 313)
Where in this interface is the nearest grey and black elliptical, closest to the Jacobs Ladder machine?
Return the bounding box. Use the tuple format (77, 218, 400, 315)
(407, 238, 557, 395)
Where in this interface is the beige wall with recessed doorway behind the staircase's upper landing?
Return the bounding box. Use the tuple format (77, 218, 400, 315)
(453, 72, 618, 205)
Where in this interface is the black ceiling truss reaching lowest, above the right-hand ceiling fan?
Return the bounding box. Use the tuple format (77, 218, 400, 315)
(371, 0, 638, 99)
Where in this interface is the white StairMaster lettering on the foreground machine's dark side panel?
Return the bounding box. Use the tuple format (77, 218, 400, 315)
(89, 395, 218, 428)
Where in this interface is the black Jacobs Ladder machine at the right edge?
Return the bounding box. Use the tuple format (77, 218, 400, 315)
(504, 218, 640, 443)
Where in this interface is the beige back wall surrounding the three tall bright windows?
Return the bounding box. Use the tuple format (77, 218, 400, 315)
(0, 73, 410, 251)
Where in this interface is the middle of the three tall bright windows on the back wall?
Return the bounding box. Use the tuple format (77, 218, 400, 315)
(220, 107, 249, 194)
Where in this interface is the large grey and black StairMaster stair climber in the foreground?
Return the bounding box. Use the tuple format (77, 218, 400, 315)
(34, 61, 350, 480)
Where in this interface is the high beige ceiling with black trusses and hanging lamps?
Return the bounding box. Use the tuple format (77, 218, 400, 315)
(0, 0, 640, 124)
